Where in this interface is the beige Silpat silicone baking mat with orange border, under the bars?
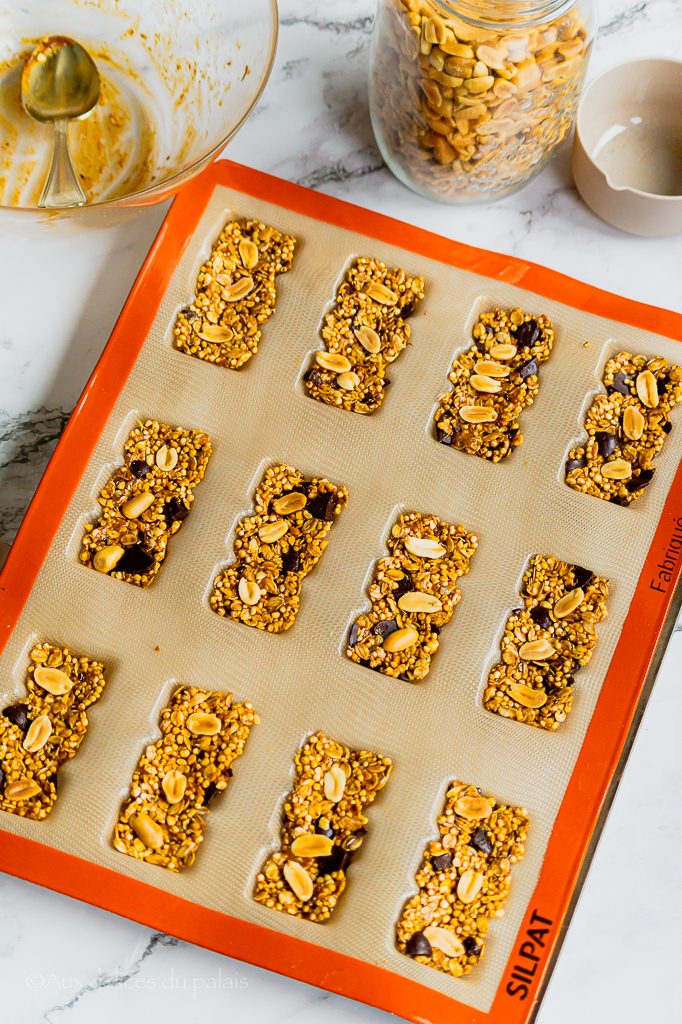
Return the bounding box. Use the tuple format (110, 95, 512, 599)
(0, 162, 682, 1024)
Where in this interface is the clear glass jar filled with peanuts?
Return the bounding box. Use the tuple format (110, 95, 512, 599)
(370, 0, 596, 203)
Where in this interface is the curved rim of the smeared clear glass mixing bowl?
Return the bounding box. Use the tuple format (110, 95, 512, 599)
(0, 0, 280, 211)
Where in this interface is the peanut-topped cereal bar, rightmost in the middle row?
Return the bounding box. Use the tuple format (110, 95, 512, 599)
(483, 555, 608, 729)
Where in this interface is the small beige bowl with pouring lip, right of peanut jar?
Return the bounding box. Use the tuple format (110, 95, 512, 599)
(572, 57, 682, 238)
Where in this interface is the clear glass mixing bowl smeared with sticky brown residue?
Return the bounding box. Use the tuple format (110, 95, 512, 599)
(0, 0, 278, 219)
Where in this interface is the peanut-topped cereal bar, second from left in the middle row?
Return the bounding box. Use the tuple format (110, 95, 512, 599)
(211, 463, 348, 633)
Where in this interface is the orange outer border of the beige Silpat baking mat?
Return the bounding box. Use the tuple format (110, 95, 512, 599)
(0, 161, 682, 1024)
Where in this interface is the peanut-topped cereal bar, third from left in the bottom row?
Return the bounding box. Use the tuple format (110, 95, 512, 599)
(254, 732, 391, 922)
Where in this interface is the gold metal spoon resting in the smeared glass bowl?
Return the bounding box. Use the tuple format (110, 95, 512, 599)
(22, 36, 99, 209)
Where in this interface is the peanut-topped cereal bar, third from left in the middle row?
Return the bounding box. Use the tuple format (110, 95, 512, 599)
(346, 512, 478, 683)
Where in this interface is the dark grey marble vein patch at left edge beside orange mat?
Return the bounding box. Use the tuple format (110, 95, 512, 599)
(0, 408, 71, 542)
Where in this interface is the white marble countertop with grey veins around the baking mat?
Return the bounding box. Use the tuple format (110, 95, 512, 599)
(0, 0, 682, 1024)
